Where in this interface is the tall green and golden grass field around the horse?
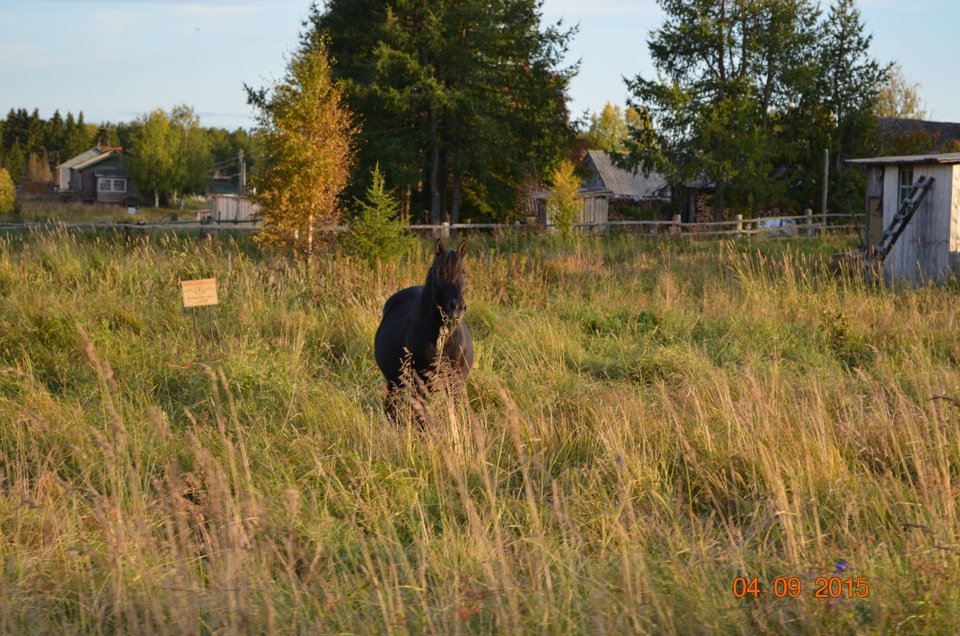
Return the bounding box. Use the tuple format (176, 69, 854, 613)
(0, 226, 960, 634)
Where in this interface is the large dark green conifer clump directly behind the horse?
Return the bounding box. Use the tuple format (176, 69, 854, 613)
(310, 0, 576, 223)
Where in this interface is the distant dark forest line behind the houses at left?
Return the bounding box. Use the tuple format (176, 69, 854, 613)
(0, 108, 258, 193)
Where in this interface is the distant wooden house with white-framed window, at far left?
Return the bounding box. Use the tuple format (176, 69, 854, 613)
(57, 148, 140, 205)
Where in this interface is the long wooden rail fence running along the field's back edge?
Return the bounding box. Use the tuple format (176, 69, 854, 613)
(0, 214, 863, 237)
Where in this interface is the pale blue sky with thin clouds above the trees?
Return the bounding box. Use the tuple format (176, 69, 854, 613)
(0, 0, 960, 130)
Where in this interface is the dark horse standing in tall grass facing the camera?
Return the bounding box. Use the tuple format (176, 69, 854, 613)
(373, 239, 473, 419)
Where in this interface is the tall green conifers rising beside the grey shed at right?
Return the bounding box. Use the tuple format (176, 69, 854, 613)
(625, 0, 884, 220)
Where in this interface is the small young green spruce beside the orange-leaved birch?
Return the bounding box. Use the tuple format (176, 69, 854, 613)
(347, 166, 416, 265)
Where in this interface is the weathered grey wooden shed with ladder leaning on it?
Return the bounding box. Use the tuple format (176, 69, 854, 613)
(847, 153, 960, 284)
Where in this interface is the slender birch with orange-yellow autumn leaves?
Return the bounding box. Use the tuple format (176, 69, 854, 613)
(254, 41, 356, 259)
